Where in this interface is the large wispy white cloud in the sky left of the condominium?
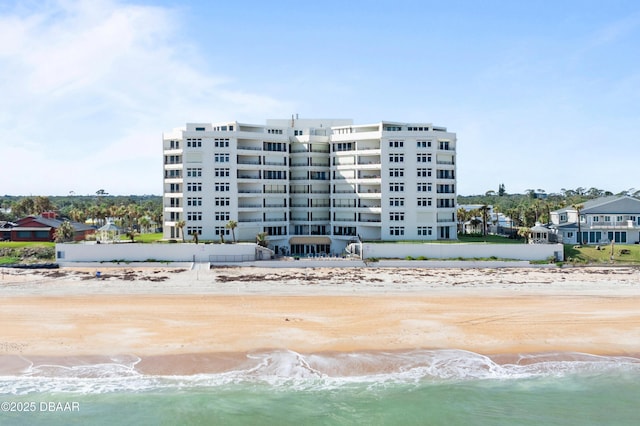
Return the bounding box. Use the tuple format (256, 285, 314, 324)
(0, 0, 290, 194)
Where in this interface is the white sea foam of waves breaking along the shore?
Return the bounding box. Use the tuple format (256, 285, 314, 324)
(0, 350, 640, 395)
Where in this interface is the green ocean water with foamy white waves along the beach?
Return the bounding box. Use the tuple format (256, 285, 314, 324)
(0, 350, 640, 426)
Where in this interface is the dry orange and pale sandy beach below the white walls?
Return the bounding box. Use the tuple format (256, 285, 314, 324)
(0, 267, 640, 372)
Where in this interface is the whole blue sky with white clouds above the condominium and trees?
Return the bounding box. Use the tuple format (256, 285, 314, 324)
(0, 0, 640, 195)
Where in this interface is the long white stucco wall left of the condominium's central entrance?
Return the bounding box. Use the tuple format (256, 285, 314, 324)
(56, 243, 260, 265)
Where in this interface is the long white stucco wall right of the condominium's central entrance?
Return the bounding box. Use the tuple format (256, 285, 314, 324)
(363, 243, 564, 260)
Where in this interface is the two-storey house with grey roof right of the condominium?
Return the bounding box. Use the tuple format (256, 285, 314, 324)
(549, 195, 640, 244)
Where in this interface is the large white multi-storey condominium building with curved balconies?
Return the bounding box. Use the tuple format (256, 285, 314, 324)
(163, 118, 456, 255)
